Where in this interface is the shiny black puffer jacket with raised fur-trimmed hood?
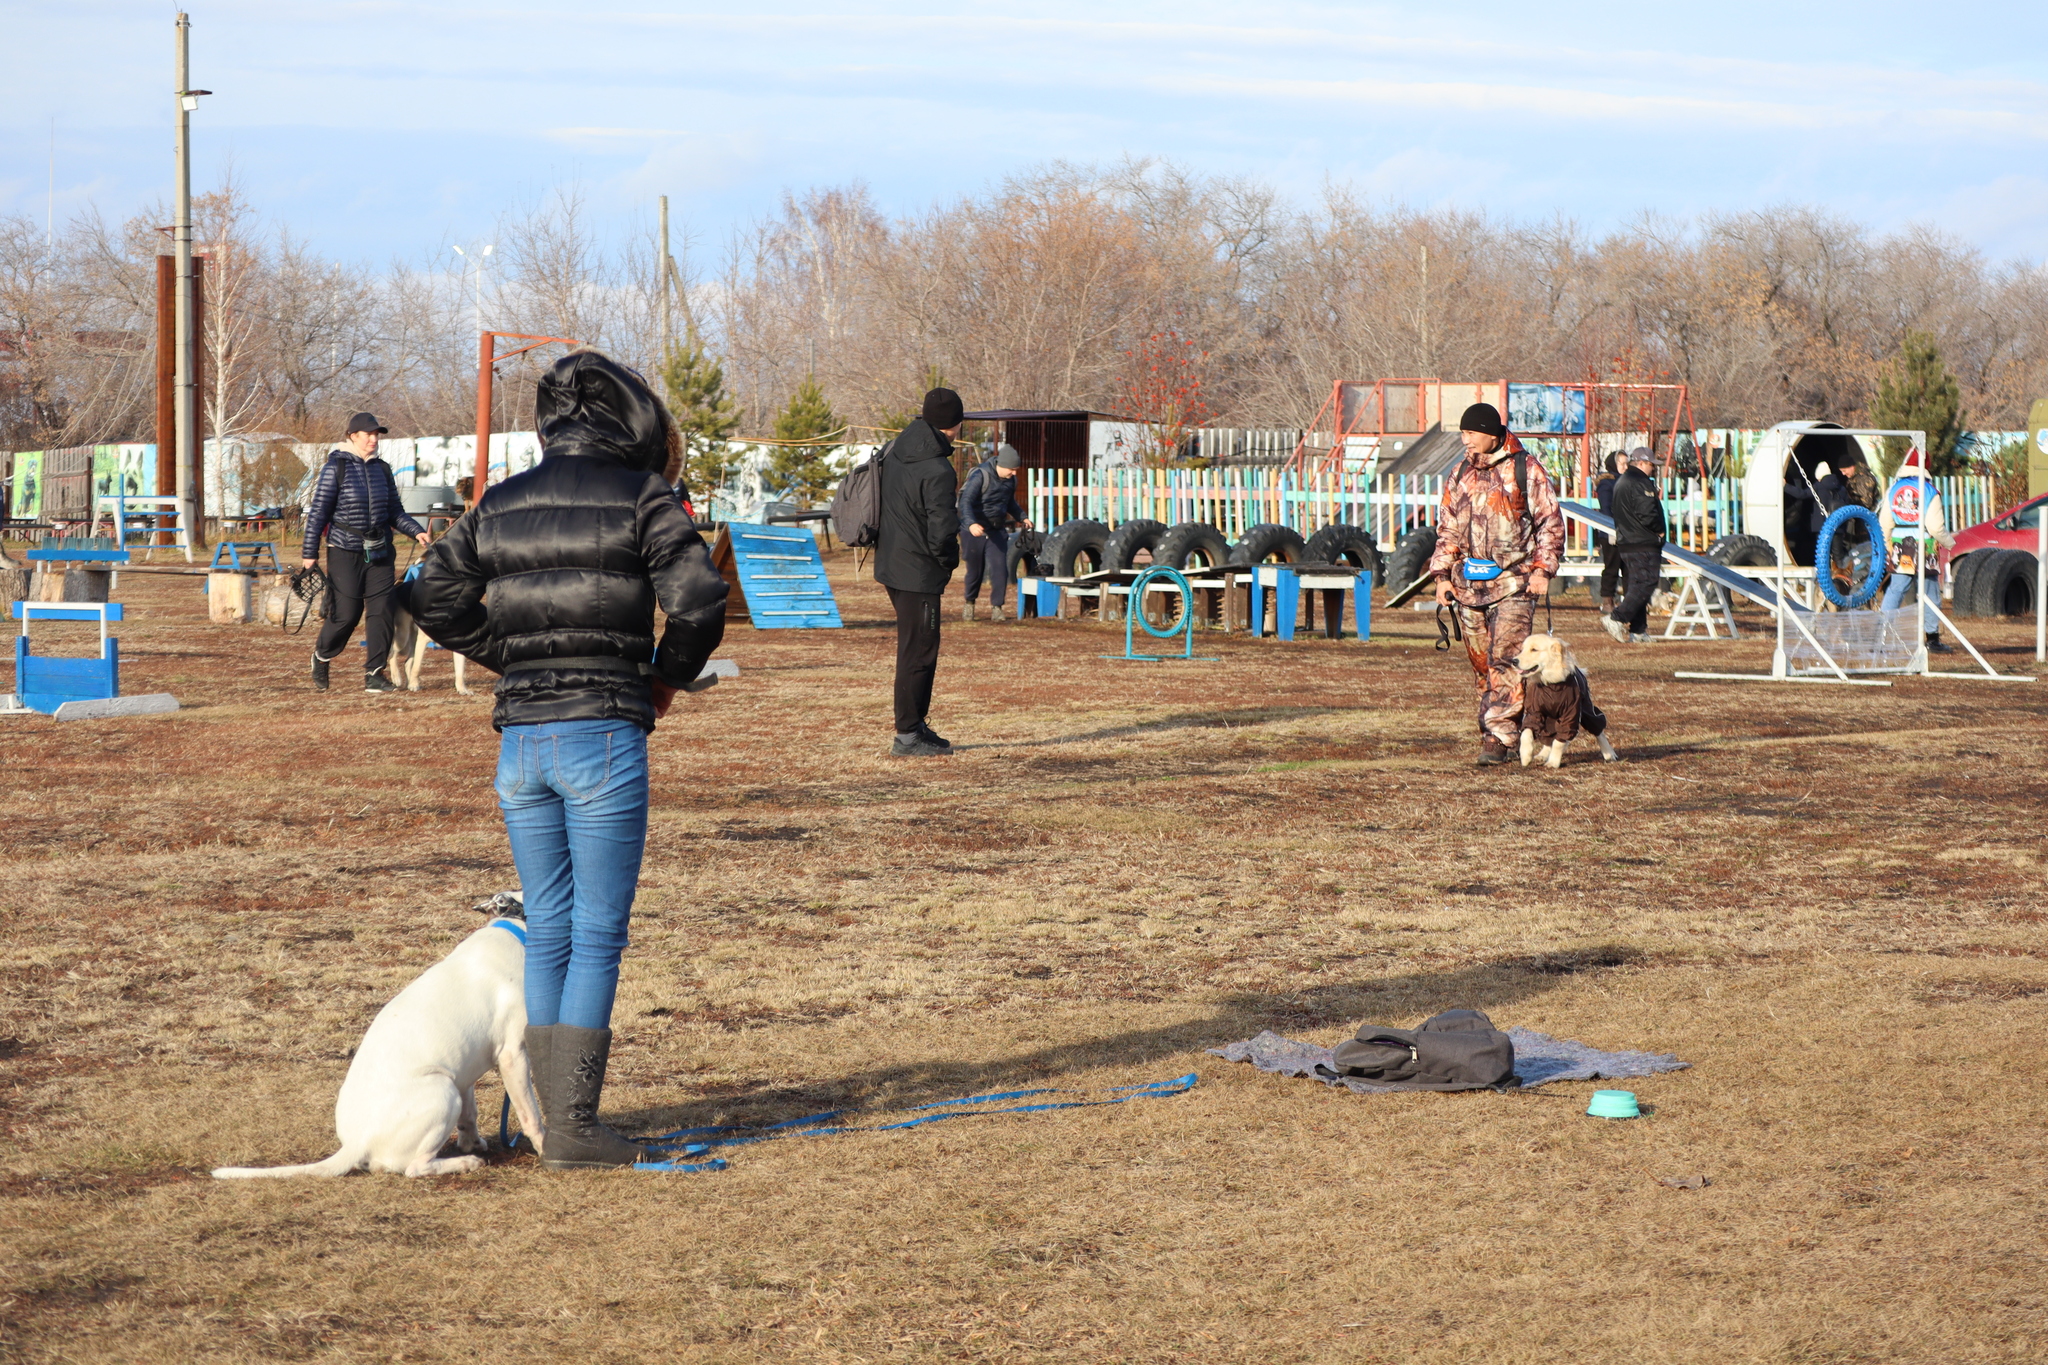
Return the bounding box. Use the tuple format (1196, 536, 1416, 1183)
(410, 350, 725, 731)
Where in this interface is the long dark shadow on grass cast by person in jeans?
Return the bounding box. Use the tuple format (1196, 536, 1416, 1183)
(606, 943, 1647, 1132)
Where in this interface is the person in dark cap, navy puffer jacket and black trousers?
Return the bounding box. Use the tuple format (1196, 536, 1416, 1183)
(299, 411, 428, 692)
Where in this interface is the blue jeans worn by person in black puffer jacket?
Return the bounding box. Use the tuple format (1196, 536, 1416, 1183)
(496, 720, 647, 1029)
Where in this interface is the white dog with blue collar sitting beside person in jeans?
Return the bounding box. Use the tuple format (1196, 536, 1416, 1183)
(213, 912, 547, 1181)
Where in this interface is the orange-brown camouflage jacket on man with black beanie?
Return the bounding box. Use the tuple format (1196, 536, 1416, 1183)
(1430, 436, 1565, 606)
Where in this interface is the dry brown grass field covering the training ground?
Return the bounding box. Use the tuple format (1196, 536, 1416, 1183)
(0, 559, 2048, 1363)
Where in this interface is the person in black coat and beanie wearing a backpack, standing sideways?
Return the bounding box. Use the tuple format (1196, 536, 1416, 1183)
(874, 389, 967, 759)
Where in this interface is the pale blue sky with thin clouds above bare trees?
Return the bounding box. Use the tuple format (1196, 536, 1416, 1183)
(0, 0, 2048, 266)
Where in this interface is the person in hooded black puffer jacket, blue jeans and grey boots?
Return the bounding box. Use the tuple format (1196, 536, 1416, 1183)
(408, 350, 725, 1171)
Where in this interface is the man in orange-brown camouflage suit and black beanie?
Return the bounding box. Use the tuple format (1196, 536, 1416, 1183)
(1430, 403, 1565, 767)
